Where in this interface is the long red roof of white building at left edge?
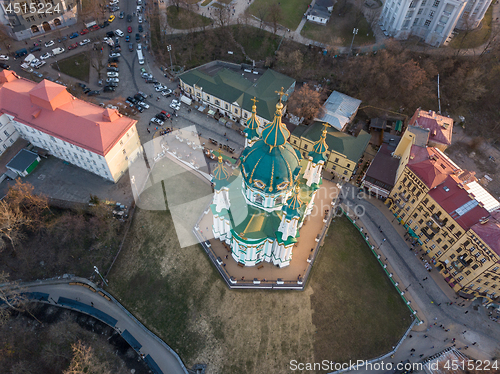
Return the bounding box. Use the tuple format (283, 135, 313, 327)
(0, 70, 137, 156)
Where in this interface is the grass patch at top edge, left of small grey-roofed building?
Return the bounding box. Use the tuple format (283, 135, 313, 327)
(248, 0, 311, 30)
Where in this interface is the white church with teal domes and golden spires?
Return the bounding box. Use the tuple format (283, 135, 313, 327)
(210, 90, 328, 267)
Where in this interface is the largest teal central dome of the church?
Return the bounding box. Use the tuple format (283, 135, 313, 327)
(241, 139, 300, 193)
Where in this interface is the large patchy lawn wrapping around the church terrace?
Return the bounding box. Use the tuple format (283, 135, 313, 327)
(108, 172, 411, 374)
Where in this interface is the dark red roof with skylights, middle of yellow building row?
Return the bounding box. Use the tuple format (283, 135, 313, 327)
(429, 175, 489, 230)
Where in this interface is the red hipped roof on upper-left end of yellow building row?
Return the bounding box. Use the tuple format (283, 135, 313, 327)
(407, 145, 457, 189)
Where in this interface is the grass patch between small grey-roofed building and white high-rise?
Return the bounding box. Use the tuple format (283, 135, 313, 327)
(301, 2, 375, 47)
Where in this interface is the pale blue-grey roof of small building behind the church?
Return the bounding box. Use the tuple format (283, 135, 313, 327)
(319, 91, 361, 131)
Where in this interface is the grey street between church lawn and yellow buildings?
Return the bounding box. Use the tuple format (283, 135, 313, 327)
(342, 184, 500, 373)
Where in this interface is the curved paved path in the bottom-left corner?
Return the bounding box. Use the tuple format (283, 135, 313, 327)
(4, 277, 188, 374)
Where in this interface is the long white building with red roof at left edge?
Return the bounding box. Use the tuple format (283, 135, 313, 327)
(0, 70, 141, 182)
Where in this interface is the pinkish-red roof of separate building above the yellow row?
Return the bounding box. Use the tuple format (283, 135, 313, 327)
(408, 108, 453, 145)
